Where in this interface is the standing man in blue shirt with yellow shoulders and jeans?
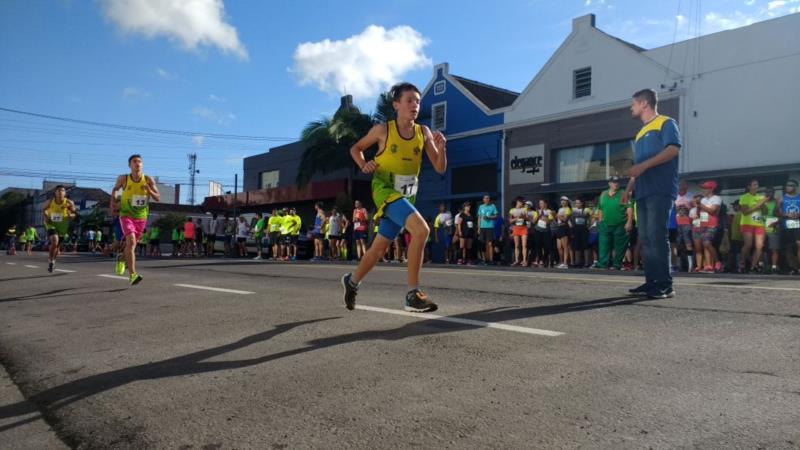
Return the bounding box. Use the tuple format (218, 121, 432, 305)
(628, 89, 681, 299)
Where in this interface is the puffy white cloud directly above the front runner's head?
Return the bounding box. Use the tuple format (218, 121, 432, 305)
(292, 25, 432, 99)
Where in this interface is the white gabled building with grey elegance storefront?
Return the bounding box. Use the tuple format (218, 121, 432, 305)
(503, 14, 800, 206)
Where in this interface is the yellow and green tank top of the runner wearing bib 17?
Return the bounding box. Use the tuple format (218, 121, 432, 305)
(372, 120, 425, 219)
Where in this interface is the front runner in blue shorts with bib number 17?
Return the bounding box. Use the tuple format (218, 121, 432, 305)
(341, 83, 447, 312)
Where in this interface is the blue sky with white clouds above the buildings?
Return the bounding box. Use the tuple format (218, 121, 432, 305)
(0, 0, 800, 199)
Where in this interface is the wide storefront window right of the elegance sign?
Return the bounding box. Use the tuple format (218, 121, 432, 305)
(555, 139, 633, 183)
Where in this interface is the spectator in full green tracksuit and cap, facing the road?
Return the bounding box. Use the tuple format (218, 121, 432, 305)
(593, 176, 633, 270)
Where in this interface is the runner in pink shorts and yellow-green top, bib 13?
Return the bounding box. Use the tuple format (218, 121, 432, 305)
(111, 155, 161, 285)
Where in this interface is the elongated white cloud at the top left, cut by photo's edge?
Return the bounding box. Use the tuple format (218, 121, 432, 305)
(100, 0, 248, 60)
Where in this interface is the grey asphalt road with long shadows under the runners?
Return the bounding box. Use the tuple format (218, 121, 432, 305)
(0, 254, 800, 449)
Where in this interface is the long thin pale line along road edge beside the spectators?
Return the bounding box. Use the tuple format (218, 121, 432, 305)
(372, 266, 800, 292)
